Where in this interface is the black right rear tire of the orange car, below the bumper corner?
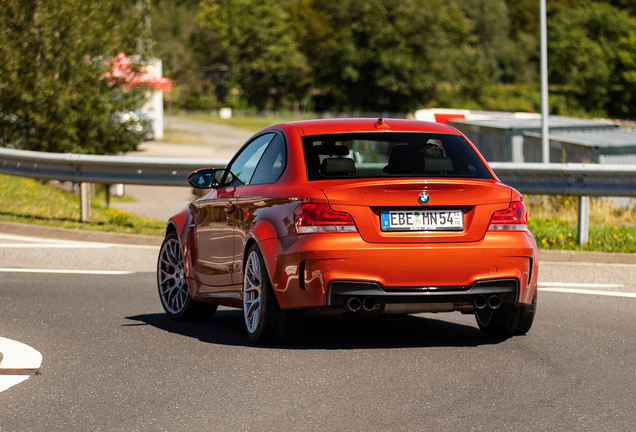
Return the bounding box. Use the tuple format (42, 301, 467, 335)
(475, 291, 537, 337)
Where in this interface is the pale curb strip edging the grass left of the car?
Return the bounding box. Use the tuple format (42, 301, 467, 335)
(0, 222, 163, 247)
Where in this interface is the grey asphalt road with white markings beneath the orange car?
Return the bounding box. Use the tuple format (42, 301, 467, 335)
(0, 233, 636, 432)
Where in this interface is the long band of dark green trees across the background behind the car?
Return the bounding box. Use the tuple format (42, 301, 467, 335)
(153, 0, 636, 118)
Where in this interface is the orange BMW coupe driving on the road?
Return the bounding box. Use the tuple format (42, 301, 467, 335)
(157, 119, 538, 343)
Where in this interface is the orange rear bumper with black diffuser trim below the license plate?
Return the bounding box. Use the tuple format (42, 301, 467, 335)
(261, 231, 538, 309)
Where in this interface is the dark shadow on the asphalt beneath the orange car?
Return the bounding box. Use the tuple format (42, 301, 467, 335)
(126, 310, 506, 350)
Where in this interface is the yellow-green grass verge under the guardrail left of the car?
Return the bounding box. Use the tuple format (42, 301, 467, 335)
(0, 174, 166, 235)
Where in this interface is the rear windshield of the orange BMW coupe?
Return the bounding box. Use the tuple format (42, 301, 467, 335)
(303, 132, 492, 180)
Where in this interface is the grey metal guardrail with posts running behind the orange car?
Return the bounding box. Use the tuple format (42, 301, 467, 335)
(0, 148, 636, 243)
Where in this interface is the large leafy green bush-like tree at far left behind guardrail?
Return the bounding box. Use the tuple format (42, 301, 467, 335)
(0, 0, 144, 154)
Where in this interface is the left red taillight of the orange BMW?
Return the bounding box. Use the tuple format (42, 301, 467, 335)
(294, 204, 358, 234)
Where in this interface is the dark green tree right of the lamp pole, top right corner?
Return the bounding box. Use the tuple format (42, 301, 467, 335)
(548, 3, 636, 118)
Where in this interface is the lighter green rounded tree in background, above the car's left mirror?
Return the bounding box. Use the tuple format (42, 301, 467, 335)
(197, 0, 308, 110)
